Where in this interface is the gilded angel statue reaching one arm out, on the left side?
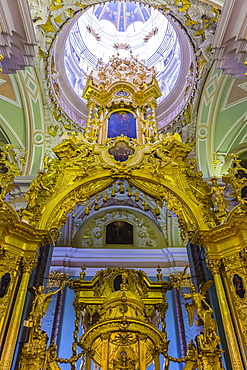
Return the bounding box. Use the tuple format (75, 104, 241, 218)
(27, 281, 67, 332)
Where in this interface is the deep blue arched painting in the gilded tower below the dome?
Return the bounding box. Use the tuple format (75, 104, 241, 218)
(108, 111, 136, 139)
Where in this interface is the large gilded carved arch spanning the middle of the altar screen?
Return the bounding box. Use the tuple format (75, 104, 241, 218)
(23, 134, 216, 239)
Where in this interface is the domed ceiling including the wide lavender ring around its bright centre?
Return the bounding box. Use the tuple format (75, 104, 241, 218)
(50, 1, 194, 127)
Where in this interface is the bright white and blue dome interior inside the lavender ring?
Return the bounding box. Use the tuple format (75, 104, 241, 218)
(65, 1, 181, 100)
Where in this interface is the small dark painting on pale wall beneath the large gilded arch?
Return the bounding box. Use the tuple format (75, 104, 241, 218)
(106, 221, 133, 244)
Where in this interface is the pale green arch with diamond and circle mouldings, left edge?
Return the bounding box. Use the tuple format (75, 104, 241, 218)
(0, 67, 45, 176)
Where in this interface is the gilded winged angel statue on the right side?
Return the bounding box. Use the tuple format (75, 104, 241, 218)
(180, 280, 213, 326)
